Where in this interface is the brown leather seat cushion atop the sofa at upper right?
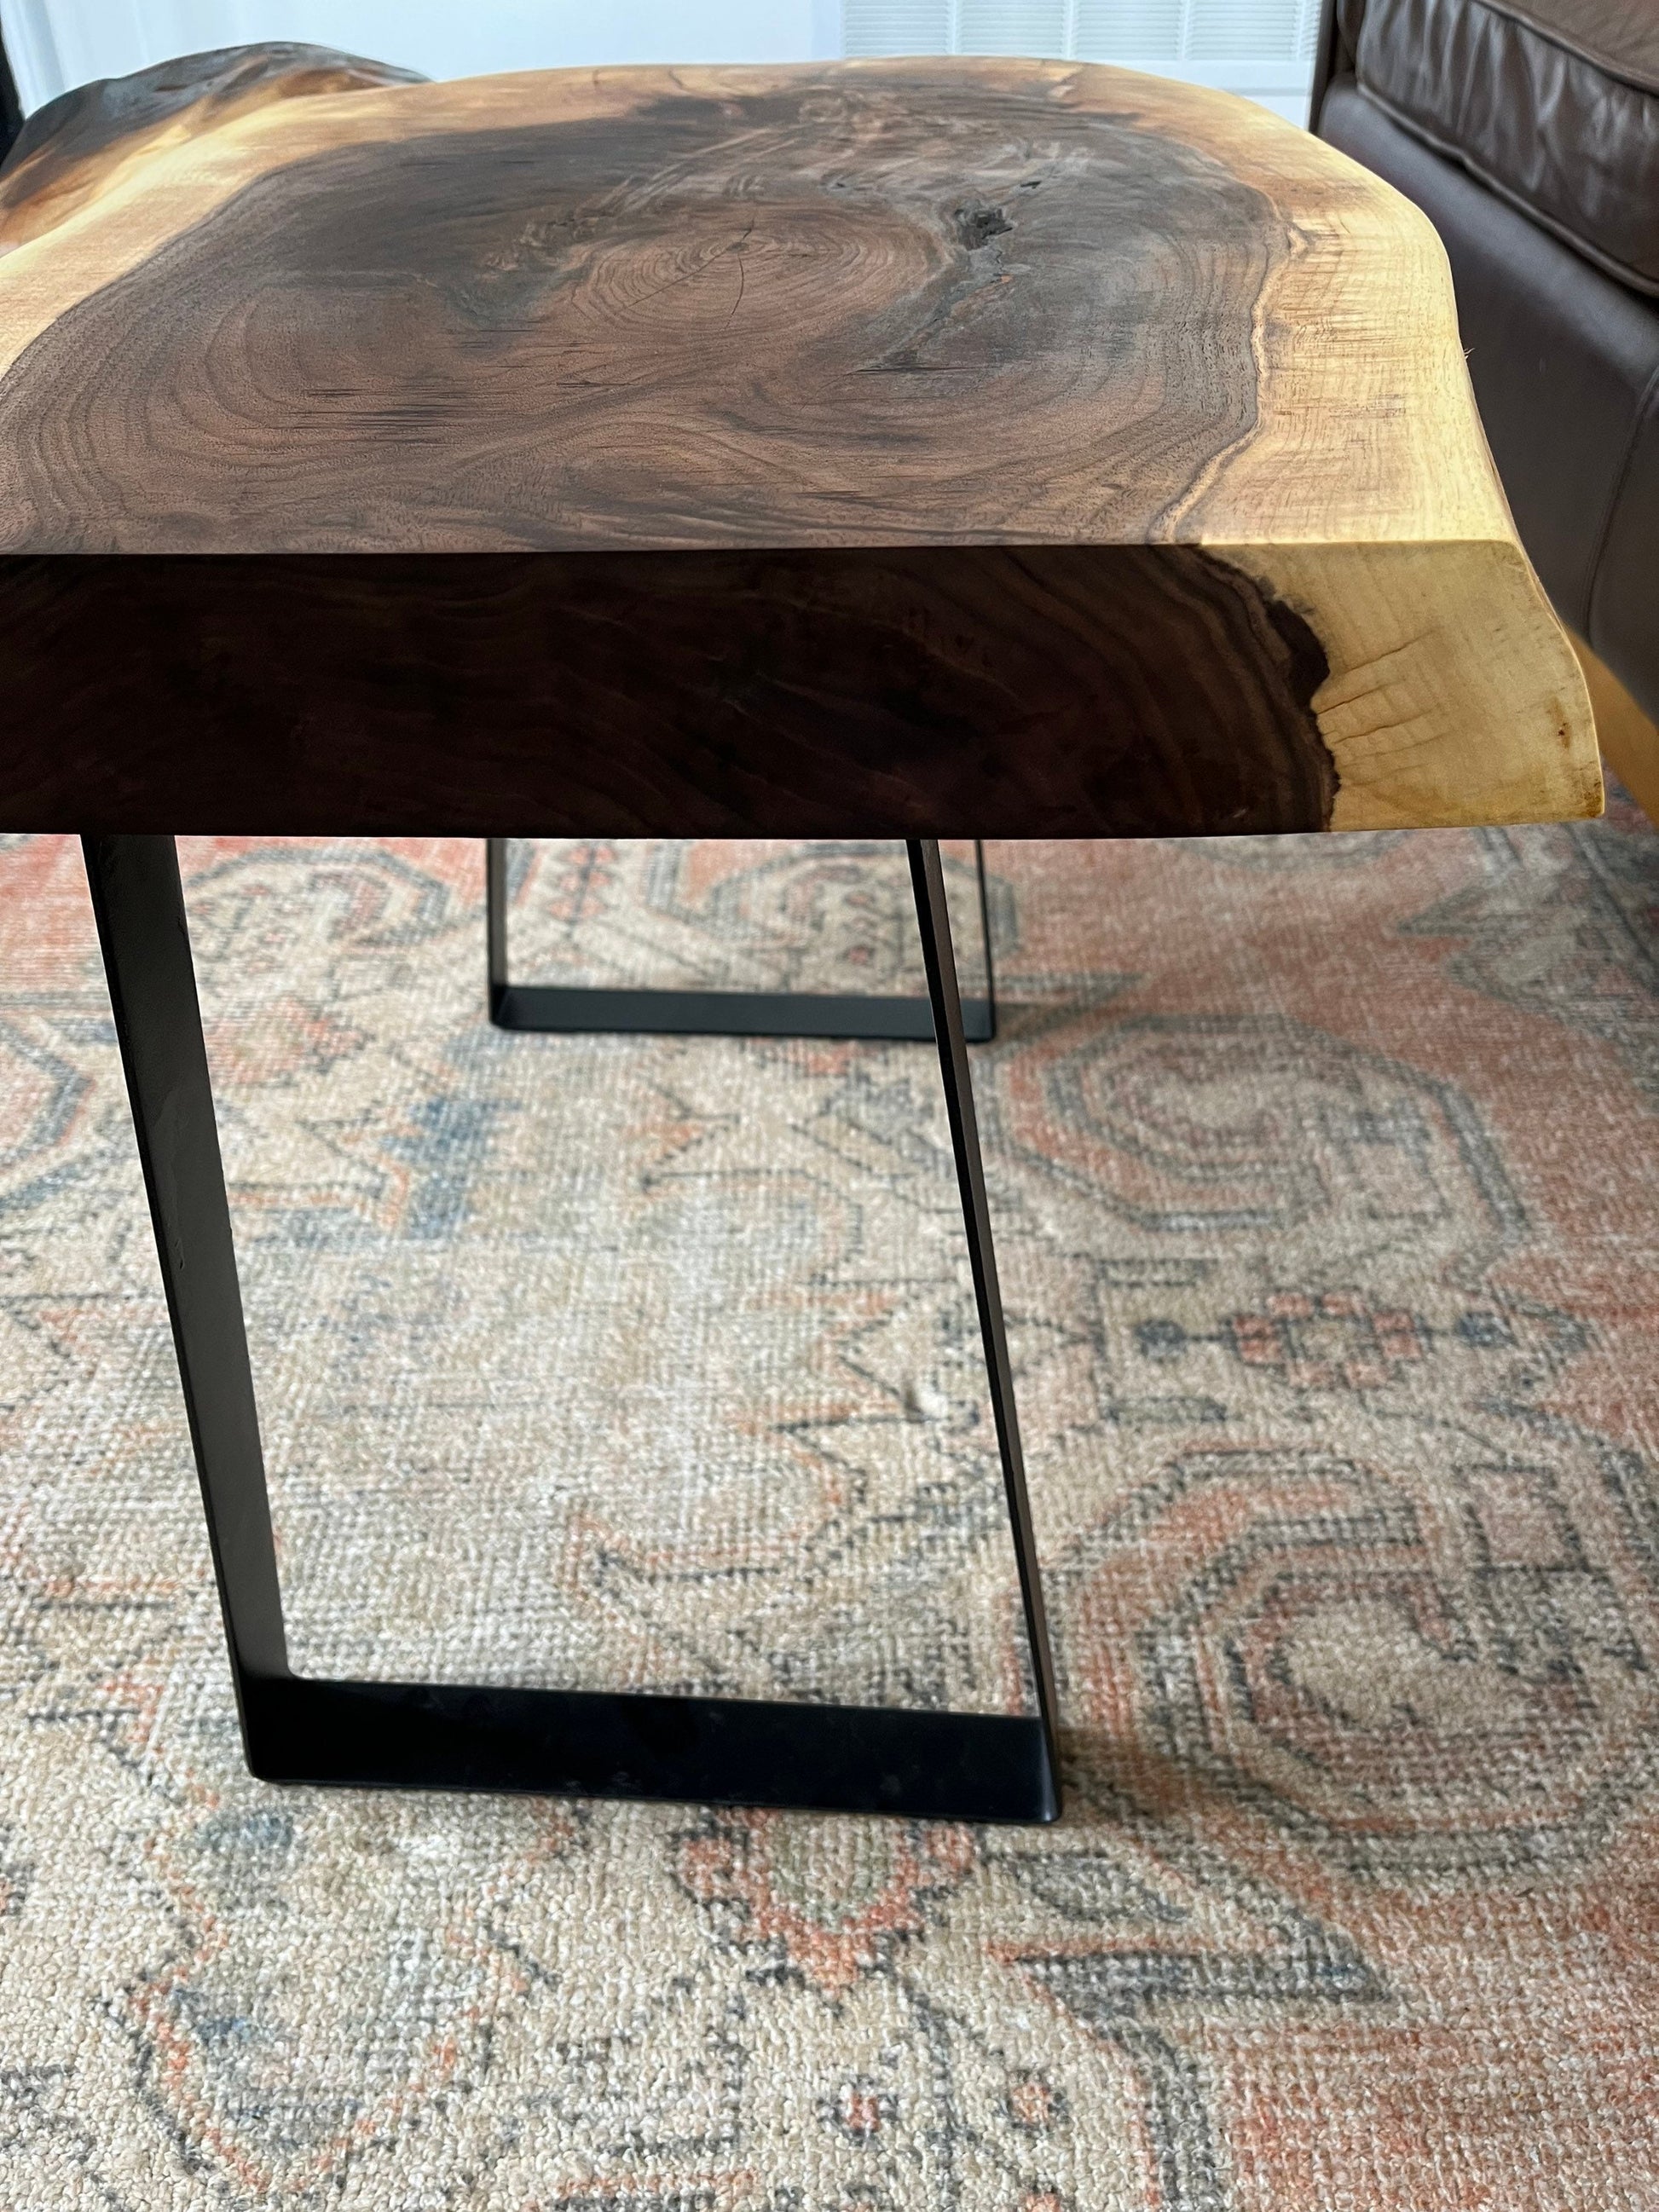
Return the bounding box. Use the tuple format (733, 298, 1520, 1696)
(1338, 0, 1659, 294)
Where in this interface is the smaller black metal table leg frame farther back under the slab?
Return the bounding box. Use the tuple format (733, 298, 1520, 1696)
(484, 836, 997, 1044)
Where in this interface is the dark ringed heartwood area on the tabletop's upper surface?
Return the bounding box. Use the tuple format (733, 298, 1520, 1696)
(0, 79, 1287, 553)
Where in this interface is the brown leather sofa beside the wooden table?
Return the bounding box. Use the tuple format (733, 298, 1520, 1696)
(1314, 0, 1659, 717)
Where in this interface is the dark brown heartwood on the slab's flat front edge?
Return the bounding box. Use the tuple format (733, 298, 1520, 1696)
(0, 546, 1336, 839)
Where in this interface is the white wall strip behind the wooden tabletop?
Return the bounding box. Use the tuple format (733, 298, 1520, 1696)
(0, 0, 1318, 122)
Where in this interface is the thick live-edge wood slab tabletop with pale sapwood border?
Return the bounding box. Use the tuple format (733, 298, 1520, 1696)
(0, 49, 1602, 839)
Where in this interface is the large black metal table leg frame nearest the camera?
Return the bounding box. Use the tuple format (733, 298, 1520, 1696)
(82, 836, 1060, 1821)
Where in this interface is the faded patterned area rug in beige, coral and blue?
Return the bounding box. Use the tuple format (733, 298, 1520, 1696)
(0, 818, 1659, 2212)
